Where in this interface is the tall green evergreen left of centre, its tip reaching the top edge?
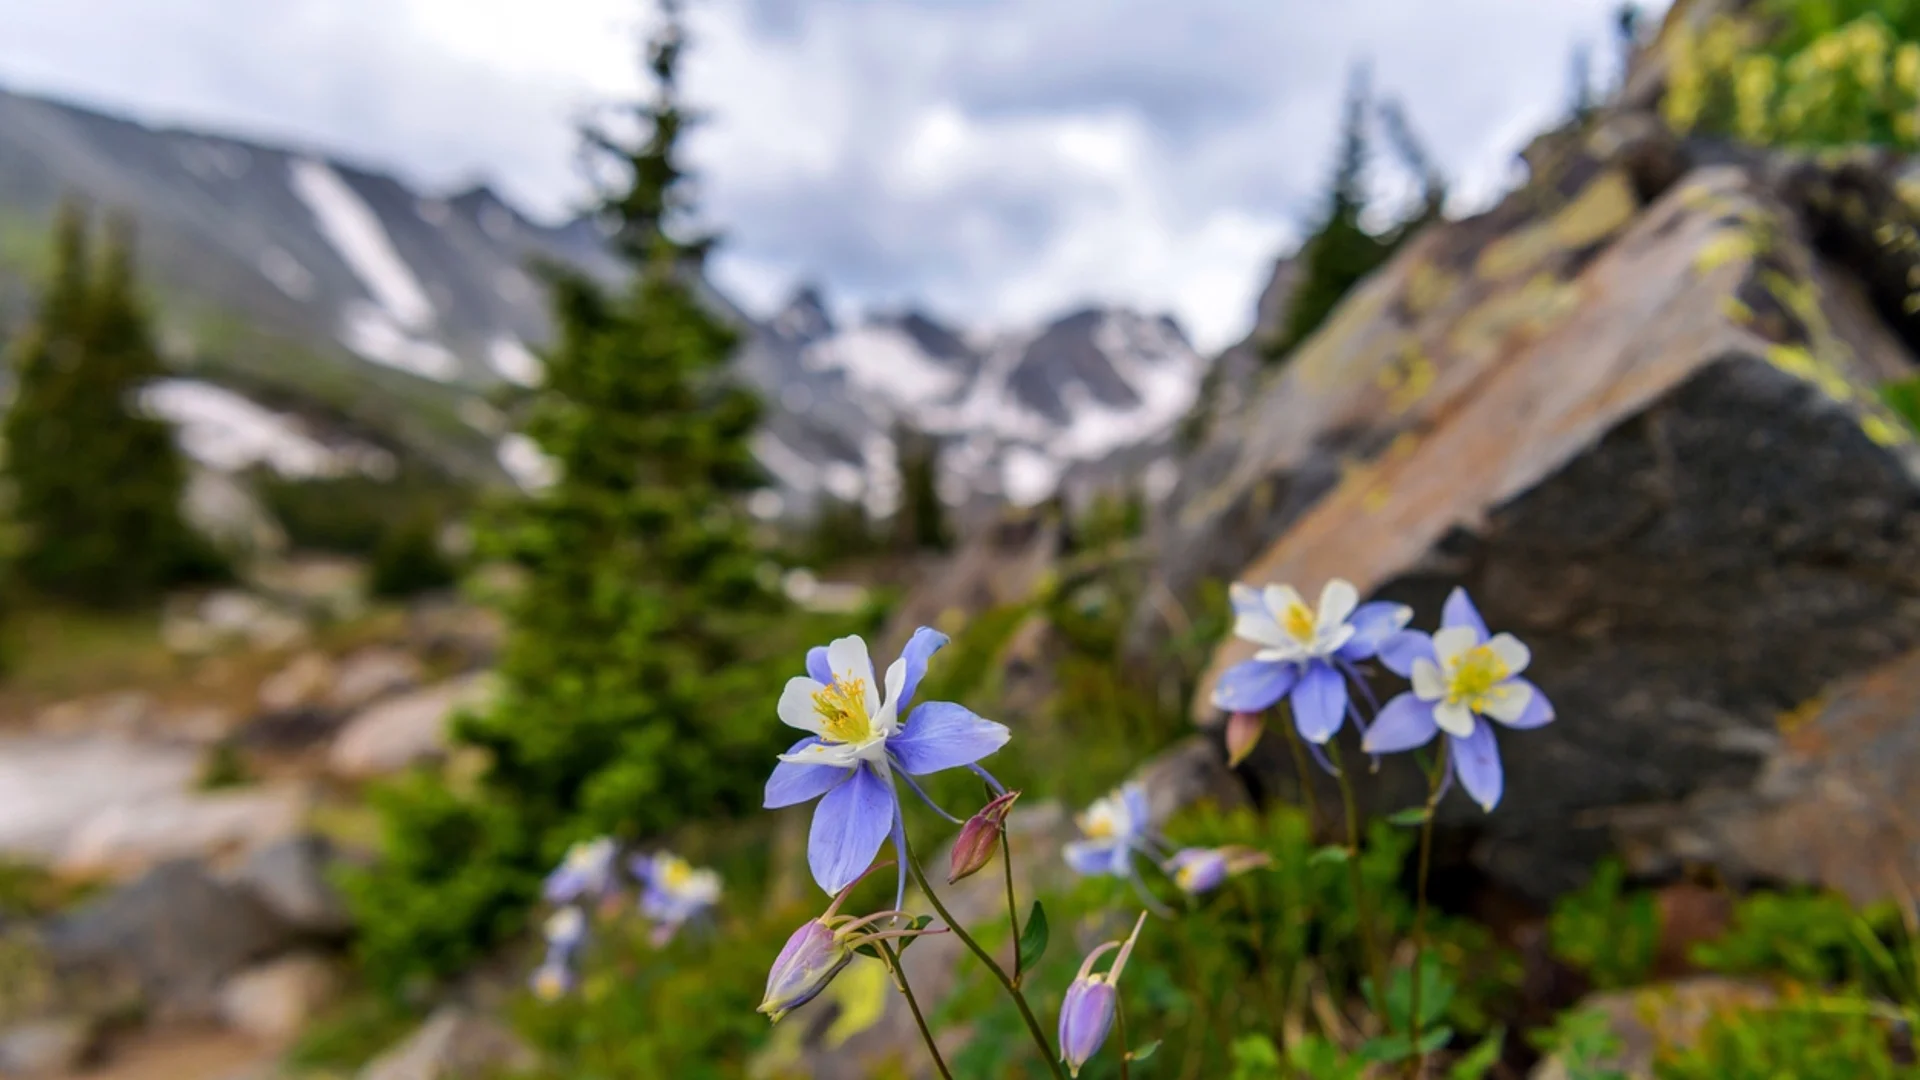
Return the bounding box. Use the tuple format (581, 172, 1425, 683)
(349, 4, 804, 984)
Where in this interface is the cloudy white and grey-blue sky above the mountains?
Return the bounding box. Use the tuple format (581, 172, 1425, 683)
(0, 0, 1663, 348)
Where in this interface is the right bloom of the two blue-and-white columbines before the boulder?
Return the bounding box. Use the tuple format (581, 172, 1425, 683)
(1363, 588, 1553, 811)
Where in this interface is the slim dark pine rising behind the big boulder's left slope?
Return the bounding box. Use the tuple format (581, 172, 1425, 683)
(1267, 73, 1392, 359)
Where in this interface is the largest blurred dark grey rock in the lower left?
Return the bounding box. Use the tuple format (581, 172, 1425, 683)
(44, 859, 294, 1019)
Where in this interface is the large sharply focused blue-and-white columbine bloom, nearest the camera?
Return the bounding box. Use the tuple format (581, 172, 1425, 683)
(766, 626, 1012, 894)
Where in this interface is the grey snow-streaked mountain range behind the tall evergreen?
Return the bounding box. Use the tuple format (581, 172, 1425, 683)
(0, 90, 1202, 513)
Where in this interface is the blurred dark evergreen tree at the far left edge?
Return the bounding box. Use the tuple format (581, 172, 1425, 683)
(4, 204, 219, 605)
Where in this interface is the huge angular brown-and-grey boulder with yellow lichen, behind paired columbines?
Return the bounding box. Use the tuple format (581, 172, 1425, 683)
(1159, 140, 1920, 899)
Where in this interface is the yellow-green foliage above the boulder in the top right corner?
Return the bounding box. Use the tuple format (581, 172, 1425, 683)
(1661, 0, 1920, 150)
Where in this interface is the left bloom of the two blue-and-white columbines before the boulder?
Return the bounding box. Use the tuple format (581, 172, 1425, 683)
(1213, 578, 1413, 746)
